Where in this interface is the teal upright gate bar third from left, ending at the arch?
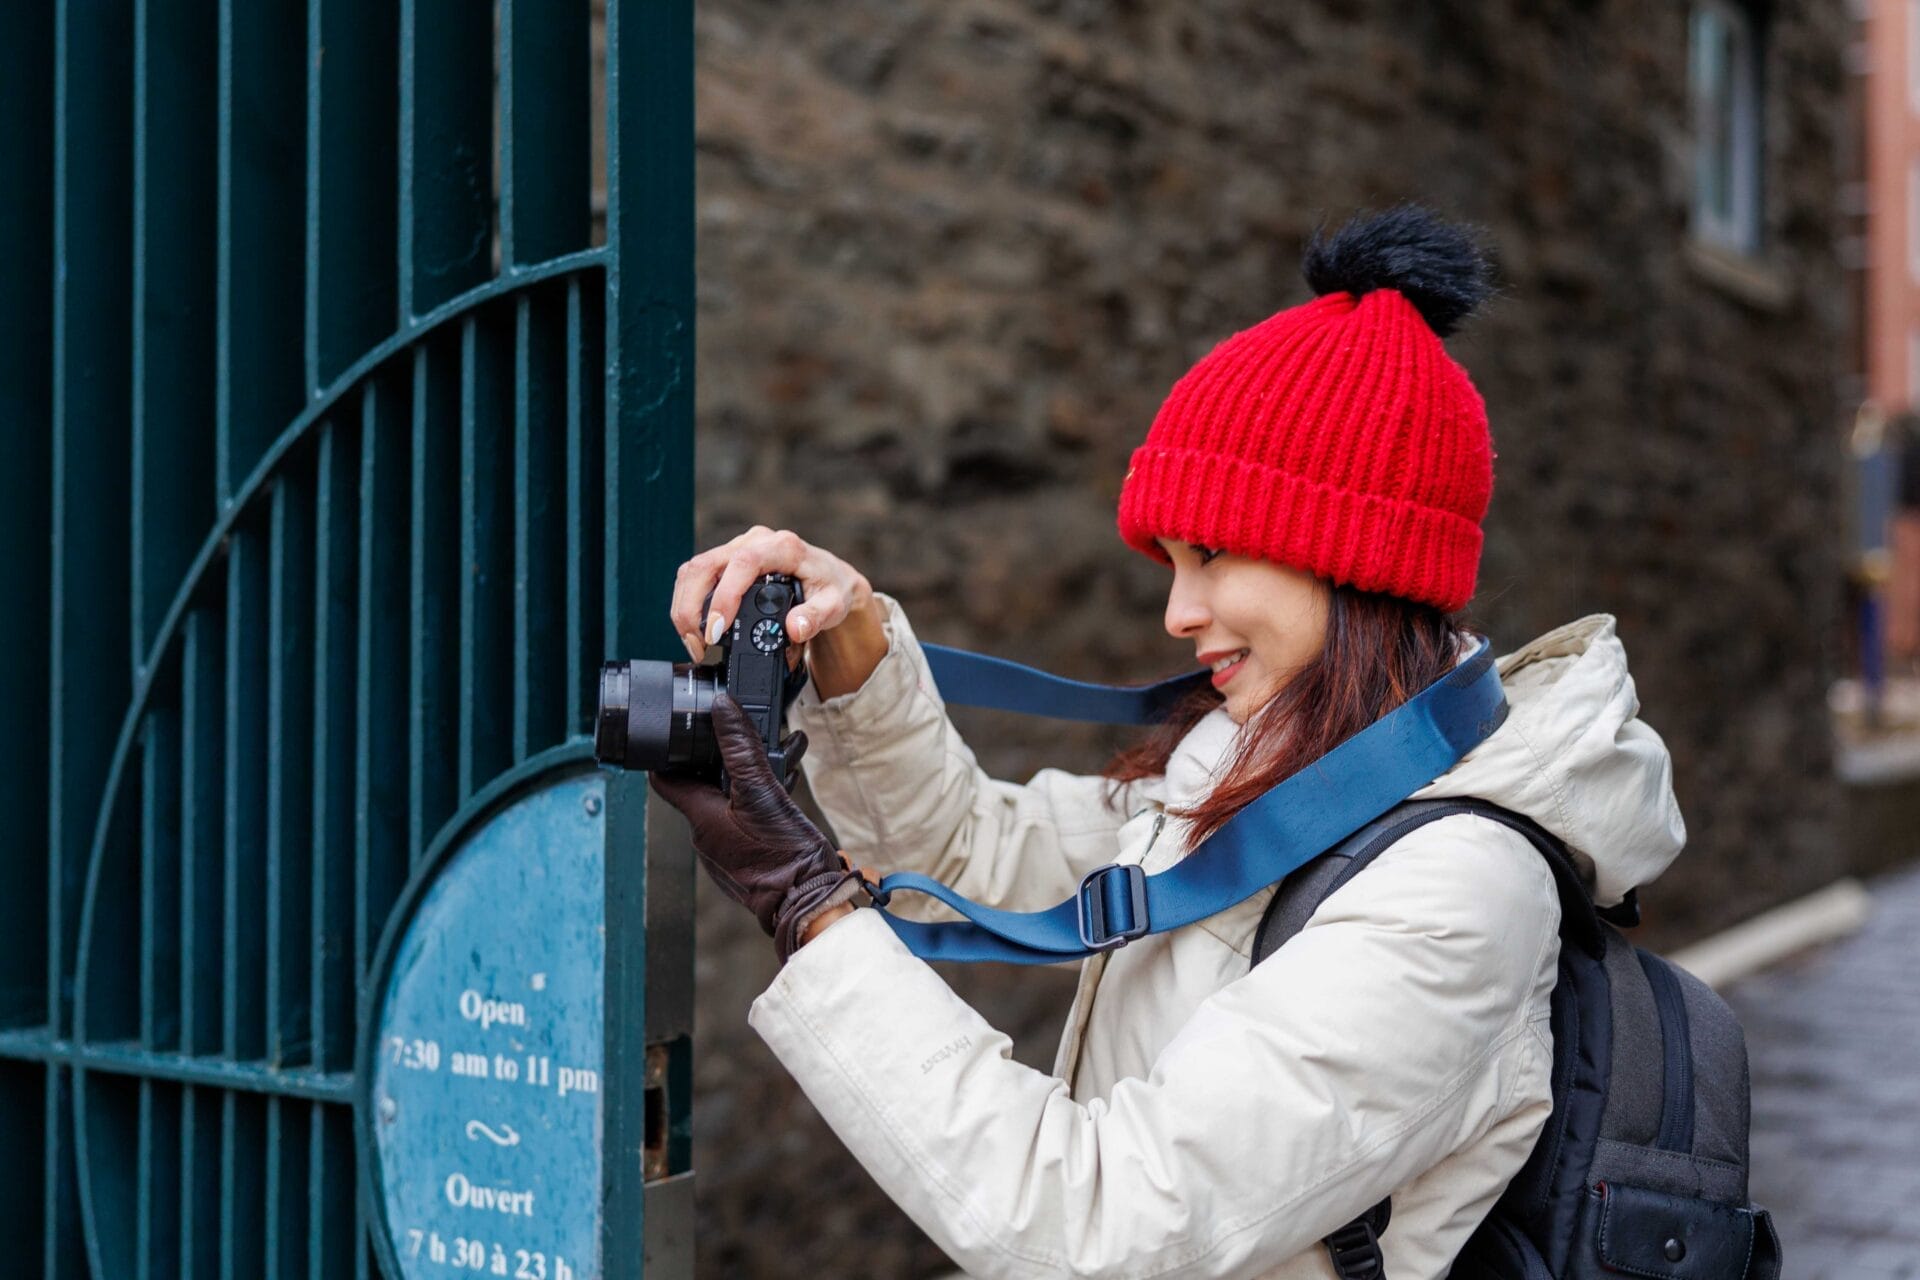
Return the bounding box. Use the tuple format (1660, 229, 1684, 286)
(129, 0, 218, 668)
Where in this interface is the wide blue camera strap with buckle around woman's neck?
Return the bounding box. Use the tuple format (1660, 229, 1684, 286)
(876, 641, 1507, 965)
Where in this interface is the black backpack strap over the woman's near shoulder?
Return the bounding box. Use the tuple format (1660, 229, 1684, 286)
(1254, 796, 1605, 965)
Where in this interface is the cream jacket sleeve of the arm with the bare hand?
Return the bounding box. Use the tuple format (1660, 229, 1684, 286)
(787, 593, 1140, 915)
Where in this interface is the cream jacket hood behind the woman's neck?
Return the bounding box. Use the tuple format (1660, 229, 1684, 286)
(1415, 614, 1686, 906)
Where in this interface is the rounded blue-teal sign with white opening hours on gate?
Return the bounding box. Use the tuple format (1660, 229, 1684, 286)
(371, 773, 607, 1280)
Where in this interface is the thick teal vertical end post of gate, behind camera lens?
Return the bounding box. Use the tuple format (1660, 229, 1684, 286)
(601, 0, 693, 1280)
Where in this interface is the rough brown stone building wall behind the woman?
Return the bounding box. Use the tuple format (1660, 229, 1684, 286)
(695, 0, 1849, 1276)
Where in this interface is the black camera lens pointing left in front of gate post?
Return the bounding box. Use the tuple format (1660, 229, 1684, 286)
(593, 662, 722, 770)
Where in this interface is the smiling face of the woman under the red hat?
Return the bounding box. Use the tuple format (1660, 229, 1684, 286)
(1158, 537, 1329, 723)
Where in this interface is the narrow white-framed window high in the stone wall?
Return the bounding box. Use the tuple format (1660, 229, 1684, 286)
(1688, 0, 1761, 253)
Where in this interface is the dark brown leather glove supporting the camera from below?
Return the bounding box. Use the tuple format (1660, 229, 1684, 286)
(651, 693, 860, 963)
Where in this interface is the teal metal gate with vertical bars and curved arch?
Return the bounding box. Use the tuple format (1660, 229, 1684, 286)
(0, 0, 693, 1280)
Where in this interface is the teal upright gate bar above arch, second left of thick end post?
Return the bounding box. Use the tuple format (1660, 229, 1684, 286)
(399, 0, 493, 322)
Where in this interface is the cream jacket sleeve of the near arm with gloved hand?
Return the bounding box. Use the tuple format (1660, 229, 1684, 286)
(751, 818, 1559, 1280)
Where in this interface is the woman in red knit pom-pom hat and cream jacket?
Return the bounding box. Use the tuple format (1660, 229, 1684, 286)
(655, 209, 1684, 1280)
